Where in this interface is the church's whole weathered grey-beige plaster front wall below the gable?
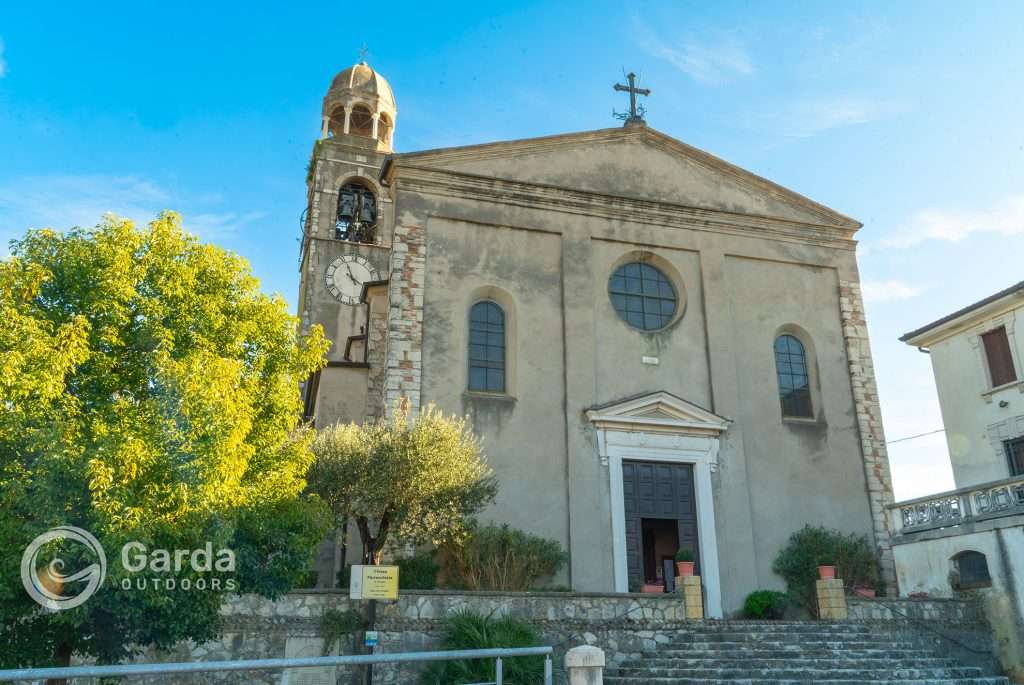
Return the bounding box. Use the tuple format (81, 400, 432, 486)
(392, 143, 871, 612)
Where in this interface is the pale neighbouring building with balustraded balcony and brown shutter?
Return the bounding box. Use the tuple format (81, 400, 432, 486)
(892, 282, 1024, 682)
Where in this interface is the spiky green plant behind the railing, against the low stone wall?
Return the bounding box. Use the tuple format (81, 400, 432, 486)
(420, 609, 544, 685)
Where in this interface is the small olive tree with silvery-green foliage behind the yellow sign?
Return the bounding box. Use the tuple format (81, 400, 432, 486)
(307, 405, 498, 564)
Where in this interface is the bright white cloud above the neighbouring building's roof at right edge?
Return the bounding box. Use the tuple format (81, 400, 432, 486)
(883, 195, 1024, 248)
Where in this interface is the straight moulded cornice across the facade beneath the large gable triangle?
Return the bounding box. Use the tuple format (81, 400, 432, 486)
(389, 164, 856, 252)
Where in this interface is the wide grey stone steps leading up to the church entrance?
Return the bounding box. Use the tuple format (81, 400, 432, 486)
(605, 620, 1009, 685)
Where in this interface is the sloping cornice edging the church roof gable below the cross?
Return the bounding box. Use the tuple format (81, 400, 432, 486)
(381, 126, 862, 232)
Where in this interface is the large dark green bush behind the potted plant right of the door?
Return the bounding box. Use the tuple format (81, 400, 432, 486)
(772, 525, 879, 615)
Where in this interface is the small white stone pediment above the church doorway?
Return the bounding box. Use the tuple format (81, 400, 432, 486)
(587, 391, 729, 434)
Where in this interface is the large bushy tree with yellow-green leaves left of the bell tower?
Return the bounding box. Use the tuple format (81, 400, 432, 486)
(0, 212, 328, 667)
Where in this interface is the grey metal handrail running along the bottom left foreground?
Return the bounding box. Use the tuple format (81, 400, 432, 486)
(0, 647, 553, 685)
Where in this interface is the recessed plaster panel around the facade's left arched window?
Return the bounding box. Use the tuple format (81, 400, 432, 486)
(423, 217, 569, 557)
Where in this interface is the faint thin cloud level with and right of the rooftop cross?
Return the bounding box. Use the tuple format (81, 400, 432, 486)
(760, 95, 909, 138)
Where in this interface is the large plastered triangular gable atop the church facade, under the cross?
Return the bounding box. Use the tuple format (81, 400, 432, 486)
(384, 126, 861, 228)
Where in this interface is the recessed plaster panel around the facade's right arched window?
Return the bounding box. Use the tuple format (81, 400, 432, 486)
(726, 256, 872, 589)
